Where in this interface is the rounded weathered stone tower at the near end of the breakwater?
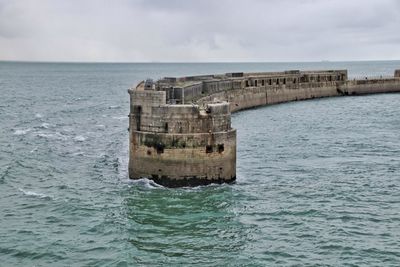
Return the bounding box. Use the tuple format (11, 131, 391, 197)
(129, 93, 236, 187)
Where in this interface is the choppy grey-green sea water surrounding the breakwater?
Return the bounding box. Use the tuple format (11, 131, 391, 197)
(0, 61, 400, 266)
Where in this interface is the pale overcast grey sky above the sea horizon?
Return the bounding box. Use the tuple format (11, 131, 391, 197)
(0, 0, 400, 62)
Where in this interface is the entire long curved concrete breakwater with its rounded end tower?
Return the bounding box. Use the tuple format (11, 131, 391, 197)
(128, 70, 400, 187)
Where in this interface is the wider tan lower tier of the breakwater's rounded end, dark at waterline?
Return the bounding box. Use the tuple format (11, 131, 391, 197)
(129, 129, 236, 187)
